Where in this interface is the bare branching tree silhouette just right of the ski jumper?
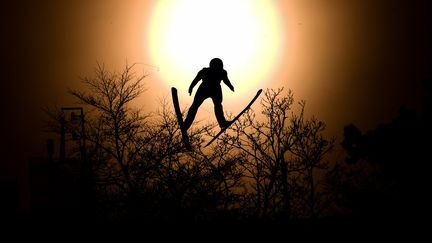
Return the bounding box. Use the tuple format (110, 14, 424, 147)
(218, 89, 333, 218)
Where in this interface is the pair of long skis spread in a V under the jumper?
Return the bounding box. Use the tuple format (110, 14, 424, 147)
(171, 87, 262, 151)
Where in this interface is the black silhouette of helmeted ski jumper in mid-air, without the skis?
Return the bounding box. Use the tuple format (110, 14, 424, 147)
(184, 58, 234, 130)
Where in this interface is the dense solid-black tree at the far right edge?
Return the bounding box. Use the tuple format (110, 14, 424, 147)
(328, 84, 432, 226)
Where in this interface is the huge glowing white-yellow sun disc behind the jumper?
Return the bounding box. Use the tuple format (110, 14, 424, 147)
(148, 0, 282, 98)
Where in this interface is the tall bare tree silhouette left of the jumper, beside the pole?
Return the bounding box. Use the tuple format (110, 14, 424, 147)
(69, 64, 147, 197)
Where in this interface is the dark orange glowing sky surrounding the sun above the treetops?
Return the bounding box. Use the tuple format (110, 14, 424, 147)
(0, 0, 432, 176)
